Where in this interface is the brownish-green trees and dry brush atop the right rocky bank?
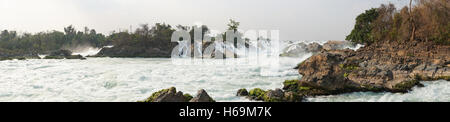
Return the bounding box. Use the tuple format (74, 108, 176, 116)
(346, 0, 450, 45)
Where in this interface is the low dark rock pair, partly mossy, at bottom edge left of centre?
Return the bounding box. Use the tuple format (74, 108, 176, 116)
(138, 87, 215, 102)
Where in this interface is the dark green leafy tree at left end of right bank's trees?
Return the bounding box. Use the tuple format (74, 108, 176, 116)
(346, 8, 379, 44)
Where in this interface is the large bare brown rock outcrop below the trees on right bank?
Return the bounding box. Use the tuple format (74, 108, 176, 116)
(296, 41, 450, 94)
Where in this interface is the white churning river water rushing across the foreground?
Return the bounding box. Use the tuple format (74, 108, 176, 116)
(0, 42, 450, 102)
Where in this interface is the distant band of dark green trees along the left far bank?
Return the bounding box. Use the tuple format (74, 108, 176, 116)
(0, 23, 175, 53)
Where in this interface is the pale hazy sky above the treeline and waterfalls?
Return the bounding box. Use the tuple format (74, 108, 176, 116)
(0, 0, 408, 40)
